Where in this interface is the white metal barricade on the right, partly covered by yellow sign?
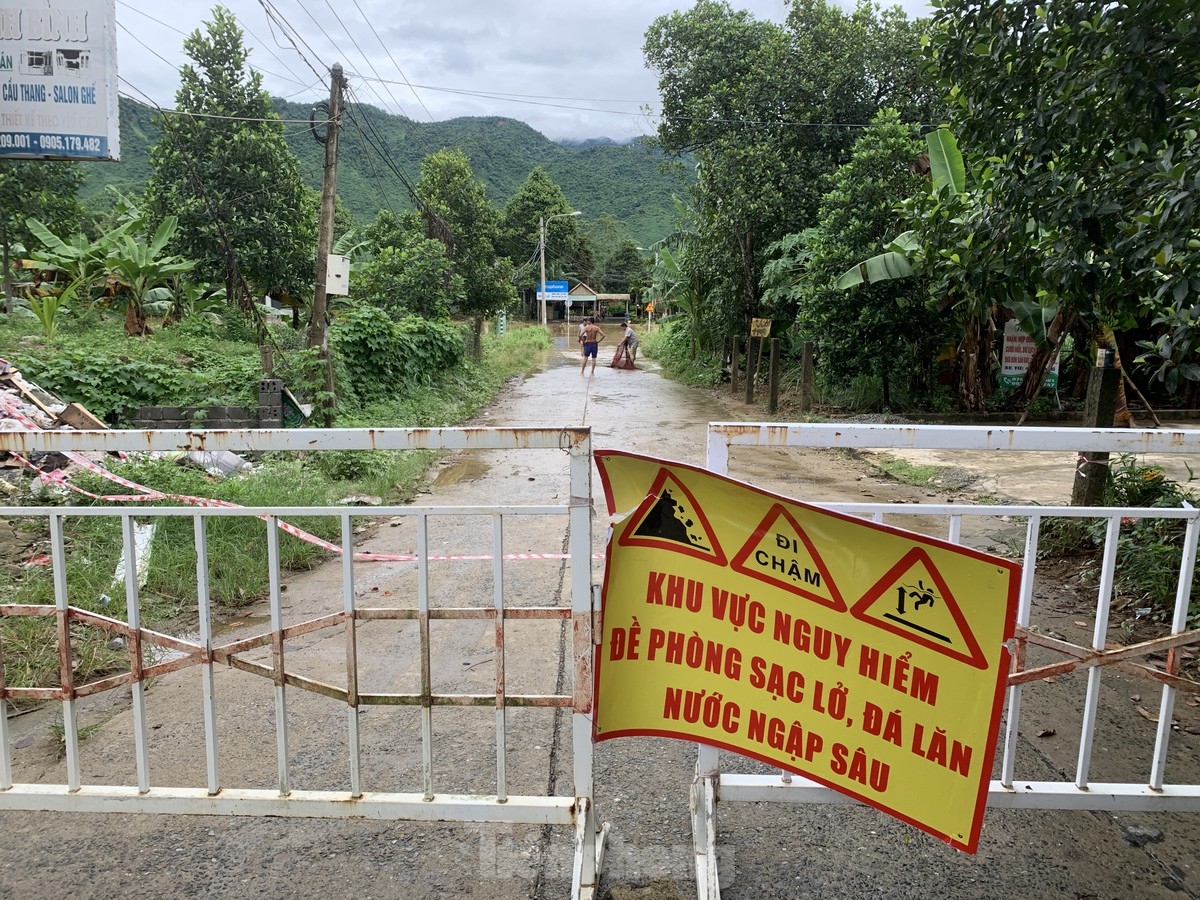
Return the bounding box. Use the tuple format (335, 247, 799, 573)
(691, 422, 1200, 898)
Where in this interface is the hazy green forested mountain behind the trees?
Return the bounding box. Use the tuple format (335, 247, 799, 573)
(80, 97, 691, 247)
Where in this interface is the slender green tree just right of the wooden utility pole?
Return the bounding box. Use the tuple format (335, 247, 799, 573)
(416, 150, 516, 359)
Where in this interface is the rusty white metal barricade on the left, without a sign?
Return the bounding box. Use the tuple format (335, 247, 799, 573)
(0, 427, 607, 898)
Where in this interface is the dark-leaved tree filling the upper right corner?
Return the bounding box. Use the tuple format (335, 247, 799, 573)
(918, 0, 1200, 398)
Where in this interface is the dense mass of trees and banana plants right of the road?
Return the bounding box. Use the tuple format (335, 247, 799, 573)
(643, 0, 1200, 424)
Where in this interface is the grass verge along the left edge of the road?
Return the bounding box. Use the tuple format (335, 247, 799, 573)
(0, 319, 553, 686)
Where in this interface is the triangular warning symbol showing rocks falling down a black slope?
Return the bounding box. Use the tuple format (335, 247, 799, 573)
(617, 469, 727, 565)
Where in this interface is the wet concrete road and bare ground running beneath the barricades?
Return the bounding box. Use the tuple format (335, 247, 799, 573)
(0, 342, 1200, 900)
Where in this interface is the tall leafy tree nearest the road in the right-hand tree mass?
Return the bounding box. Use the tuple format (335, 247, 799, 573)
(643, 0, 929, 345)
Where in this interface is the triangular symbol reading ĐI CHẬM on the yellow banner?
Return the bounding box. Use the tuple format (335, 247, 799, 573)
(730, 503, 846, 612)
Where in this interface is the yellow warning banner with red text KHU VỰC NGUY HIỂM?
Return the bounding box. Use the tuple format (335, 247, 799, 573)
(594, 451, 1020, 852)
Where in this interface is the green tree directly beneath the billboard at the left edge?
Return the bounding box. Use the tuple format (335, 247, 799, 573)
(0, 160, 83, 314)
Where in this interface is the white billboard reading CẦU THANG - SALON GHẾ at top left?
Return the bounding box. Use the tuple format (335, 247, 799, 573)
(0, 0, 121, 160)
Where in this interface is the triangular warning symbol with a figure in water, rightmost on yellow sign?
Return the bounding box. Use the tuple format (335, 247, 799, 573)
(851, 547, 988, 668)
